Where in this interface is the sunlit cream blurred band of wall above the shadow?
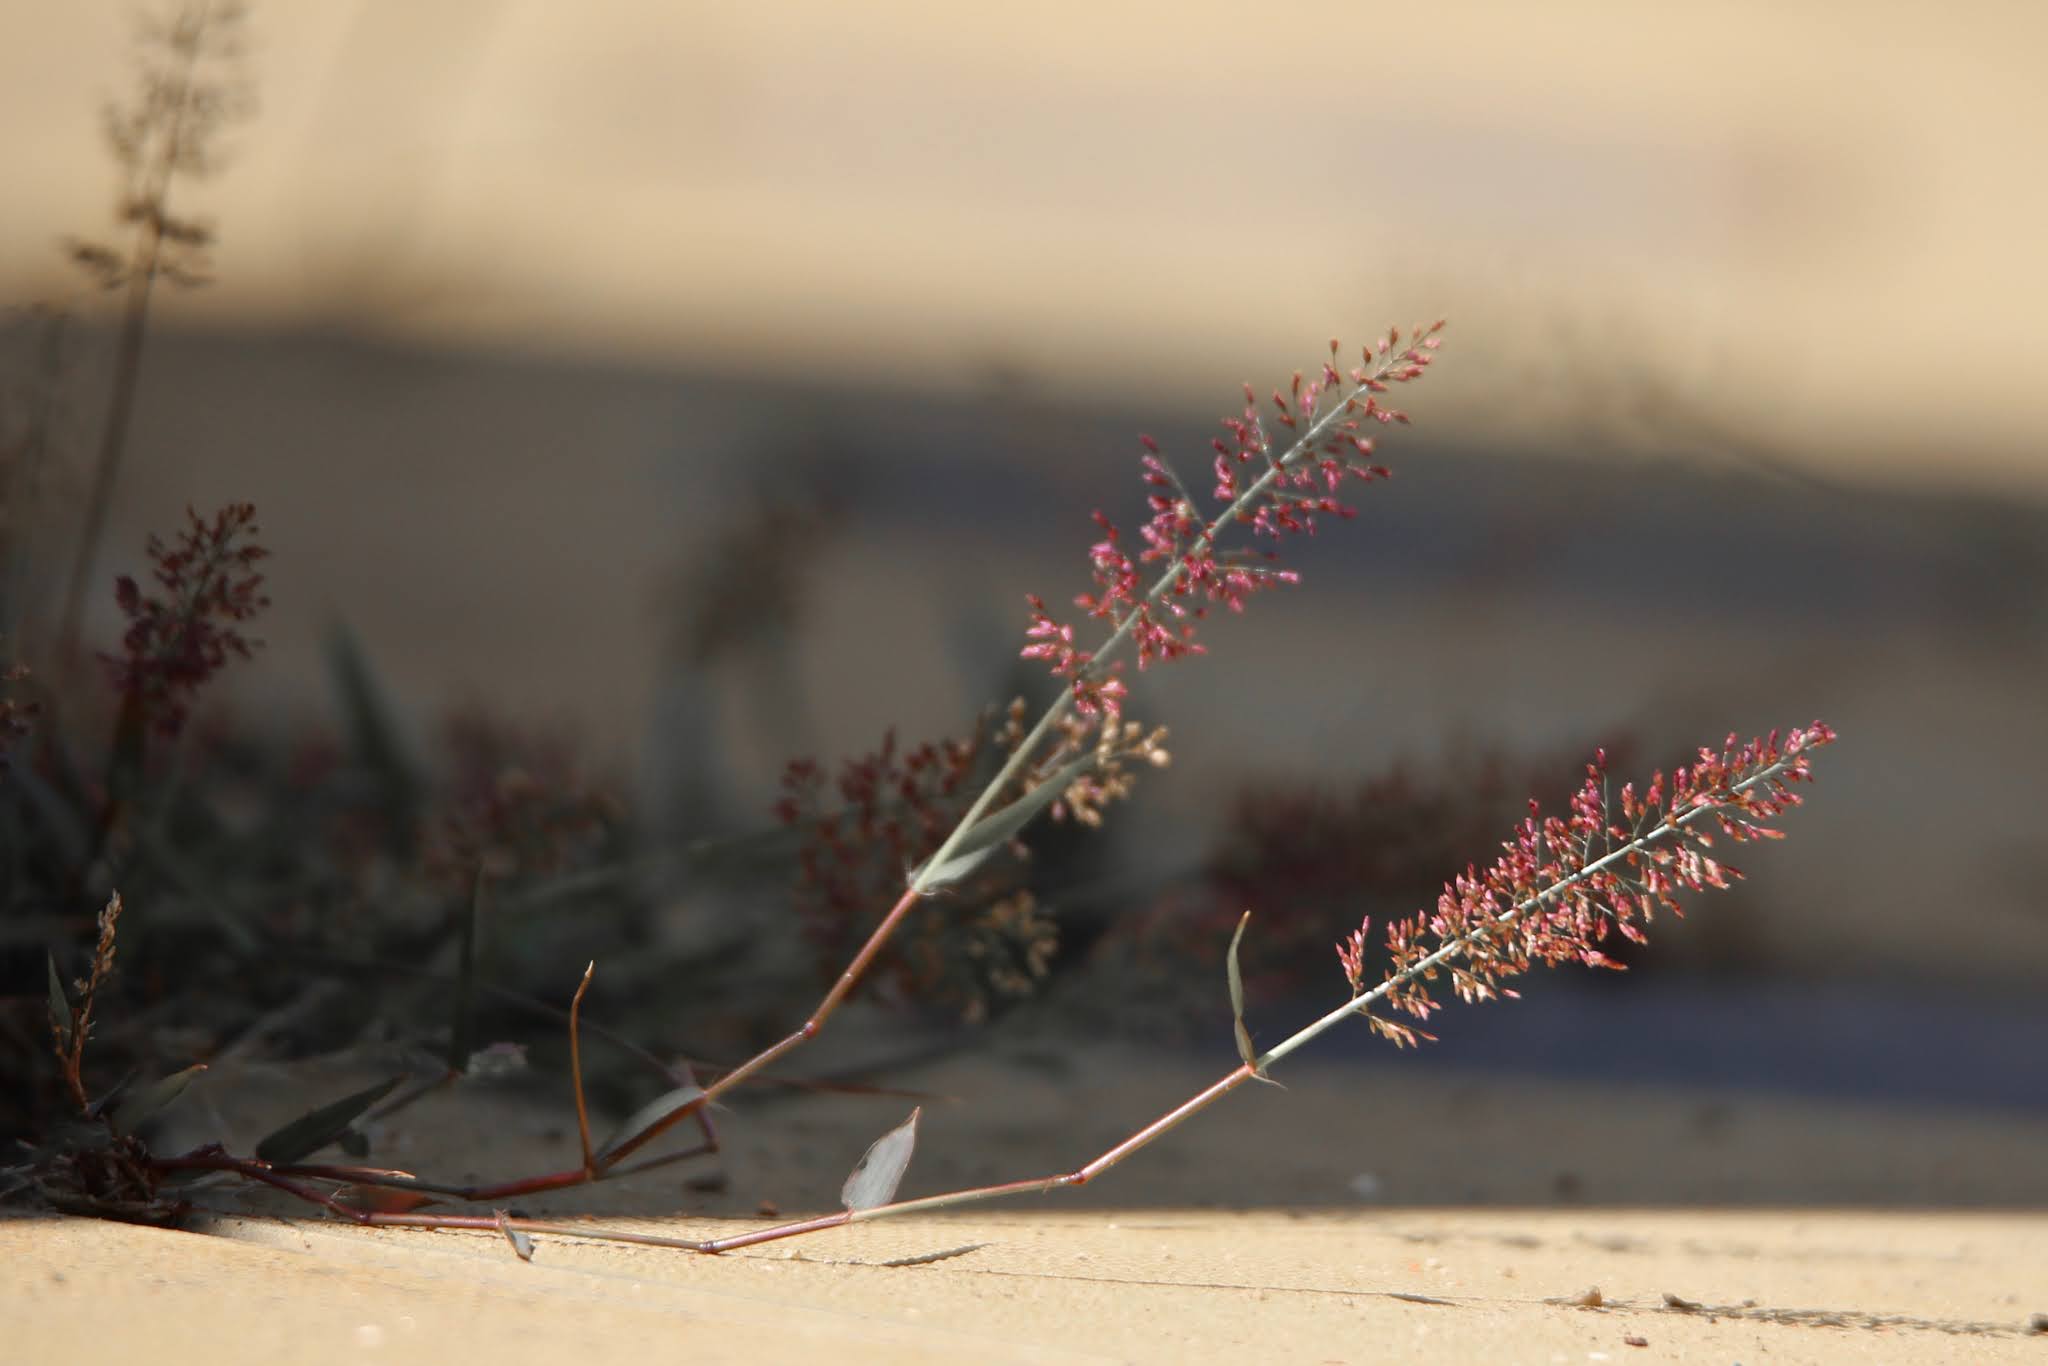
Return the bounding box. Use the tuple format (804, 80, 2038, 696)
(0, 0, 2048, 494)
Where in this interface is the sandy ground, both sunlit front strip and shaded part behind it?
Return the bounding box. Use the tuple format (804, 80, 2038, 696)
(16, 1047, 2048, 1366)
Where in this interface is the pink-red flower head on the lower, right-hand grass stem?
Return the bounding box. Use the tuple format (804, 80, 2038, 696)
(1337, 721, 1835, 1047)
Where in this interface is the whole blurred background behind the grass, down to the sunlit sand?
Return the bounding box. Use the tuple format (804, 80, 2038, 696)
(0, 0, 2048, 1202)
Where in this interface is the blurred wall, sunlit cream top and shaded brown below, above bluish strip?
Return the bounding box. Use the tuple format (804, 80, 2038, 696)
(0, 2, 2048, 1015)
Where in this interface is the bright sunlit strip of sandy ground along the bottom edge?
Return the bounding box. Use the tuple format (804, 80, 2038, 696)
(0, 1208, 2048, 1366)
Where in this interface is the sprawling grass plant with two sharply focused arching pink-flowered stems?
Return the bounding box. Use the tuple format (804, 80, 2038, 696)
(12, 324, 1833, 1255)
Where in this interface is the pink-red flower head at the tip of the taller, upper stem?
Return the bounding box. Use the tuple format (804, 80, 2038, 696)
(1022, 322, 1444, 721)
